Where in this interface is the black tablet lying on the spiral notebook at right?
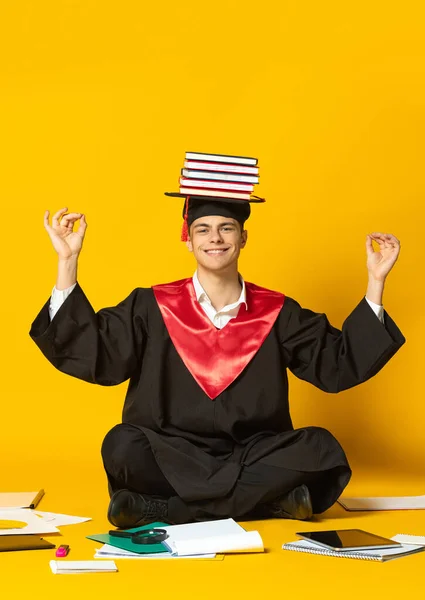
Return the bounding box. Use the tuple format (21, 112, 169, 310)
(297, 529, 400, 552)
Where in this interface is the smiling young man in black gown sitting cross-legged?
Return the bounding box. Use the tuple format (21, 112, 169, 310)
(30, 197, 405, 528)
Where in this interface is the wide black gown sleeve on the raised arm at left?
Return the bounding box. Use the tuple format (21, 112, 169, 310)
(30, 283, 146, 385)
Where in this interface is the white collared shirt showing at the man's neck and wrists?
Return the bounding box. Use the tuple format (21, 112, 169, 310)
(49, 278, 384, 329)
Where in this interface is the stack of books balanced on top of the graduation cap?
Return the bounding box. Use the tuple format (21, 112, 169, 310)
(180, 152, 259, 200)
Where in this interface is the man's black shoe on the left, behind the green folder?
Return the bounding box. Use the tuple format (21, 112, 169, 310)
(108, 490, 169, 529)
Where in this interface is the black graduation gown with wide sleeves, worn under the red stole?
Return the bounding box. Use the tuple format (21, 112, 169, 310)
(30, 284, 405, 512)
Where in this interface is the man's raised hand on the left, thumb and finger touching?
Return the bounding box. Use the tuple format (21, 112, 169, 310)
(44, 207, 87, 260)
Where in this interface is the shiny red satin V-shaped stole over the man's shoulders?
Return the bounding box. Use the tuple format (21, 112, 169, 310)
(153, 279, 285, 400)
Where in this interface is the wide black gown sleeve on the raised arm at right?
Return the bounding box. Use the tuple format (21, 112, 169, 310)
(279, 297, 406, 393)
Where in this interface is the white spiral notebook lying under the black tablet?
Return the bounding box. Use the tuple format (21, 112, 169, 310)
(282, 538, 425, 562)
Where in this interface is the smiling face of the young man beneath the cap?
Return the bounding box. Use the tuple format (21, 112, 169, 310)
(186, 216, 247, 271)
